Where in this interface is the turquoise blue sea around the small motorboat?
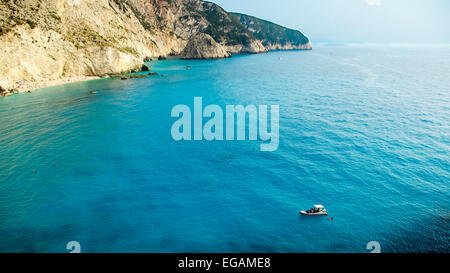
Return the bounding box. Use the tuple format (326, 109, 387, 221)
(0, 46, 450, 252)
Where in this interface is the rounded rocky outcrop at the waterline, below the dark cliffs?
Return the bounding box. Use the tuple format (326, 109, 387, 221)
(181, 33, 231, 59)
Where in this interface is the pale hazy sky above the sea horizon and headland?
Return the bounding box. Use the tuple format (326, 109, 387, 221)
(212, 0, 450, 43)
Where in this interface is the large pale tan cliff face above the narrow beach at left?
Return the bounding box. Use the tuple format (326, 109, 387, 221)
(0, 0, 158, 88)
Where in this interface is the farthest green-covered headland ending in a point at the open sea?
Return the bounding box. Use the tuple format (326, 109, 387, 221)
(230, 13, 312, 50)
